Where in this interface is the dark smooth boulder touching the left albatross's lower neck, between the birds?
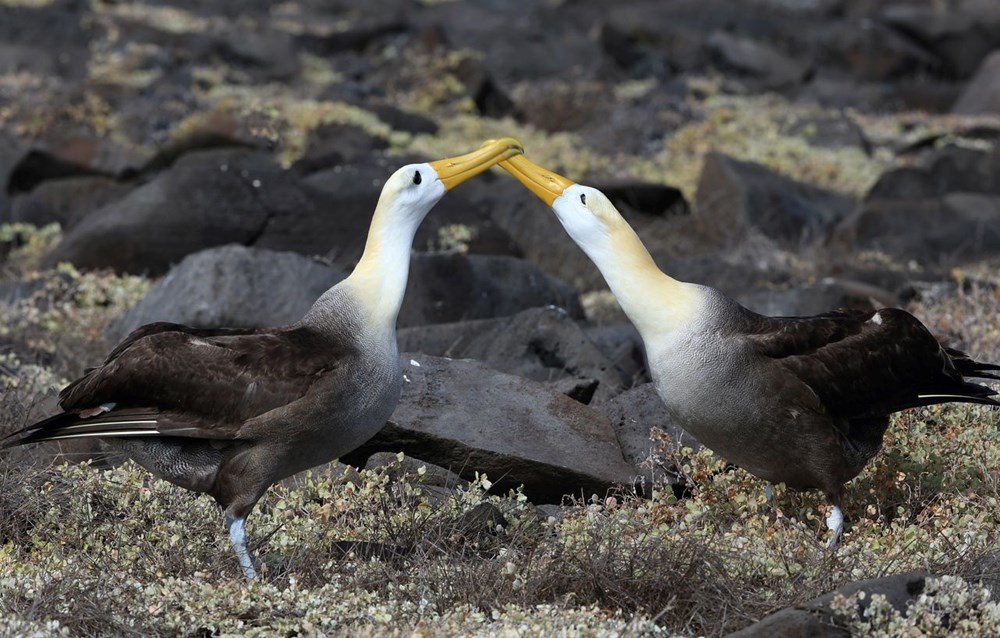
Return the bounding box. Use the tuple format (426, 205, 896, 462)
(399, 253, 583, 327)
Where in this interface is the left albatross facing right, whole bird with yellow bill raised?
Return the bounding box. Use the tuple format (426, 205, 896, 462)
(3, 138, 521, 579)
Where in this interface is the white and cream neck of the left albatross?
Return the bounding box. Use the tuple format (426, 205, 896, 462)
(305, 195, 423, 331)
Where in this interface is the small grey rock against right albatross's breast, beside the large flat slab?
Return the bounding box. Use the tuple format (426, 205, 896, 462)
(600, 383, 702, 484)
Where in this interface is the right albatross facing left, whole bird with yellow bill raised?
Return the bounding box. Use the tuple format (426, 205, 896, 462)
(500, 152, 1000, 547)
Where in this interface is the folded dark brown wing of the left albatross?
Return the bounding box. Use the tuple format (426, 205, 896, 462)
(3, 324, 344, 444)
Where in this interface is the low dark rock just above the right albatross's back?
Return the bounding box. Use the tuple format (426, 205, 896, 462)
(736, 279, 880, 317)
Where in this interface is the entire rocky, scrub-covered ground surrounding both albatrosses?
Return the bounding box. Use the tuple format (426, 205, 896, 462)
(0, 0, 1000, 636)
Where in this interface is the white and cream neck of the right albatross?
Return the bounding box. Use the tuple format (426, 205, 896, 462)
(583, 223, 700, 345)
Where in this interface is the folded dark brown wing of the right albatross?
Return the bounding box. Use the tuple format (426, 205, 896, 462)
(748, 308, 998, 420)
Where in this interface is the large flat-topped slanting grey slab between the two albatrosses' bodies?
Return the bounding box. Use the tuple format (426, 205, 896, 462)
(342, 354, 633, 503)
